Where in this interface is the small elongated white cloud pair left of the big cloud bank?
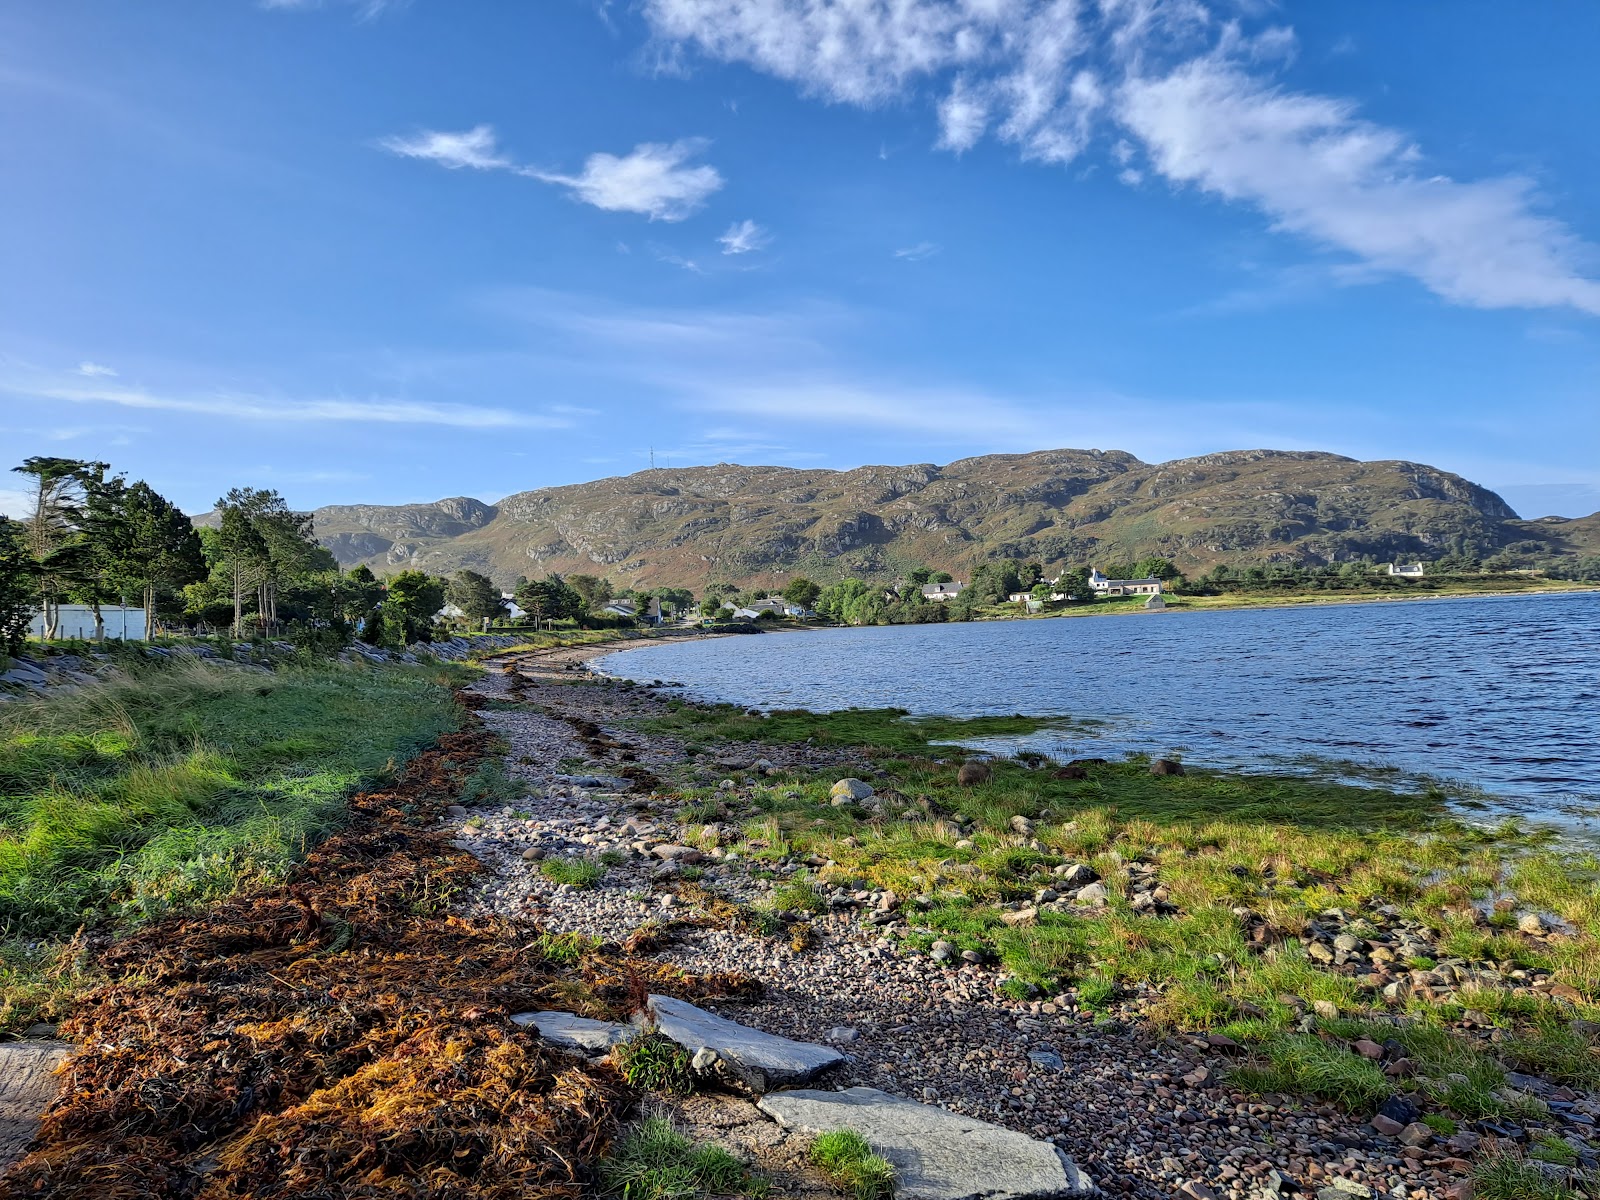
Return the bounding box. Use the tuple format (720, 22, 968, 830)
(378, 125, 723, 221)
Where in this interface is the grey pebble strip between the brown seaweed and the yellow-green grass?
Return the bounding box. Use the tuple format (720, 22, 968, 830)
(454, 648, 1510, 1200)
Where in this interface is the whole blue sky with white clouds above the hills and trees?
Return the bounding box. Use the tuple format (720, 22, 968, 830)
(0, 0, 1600, 517)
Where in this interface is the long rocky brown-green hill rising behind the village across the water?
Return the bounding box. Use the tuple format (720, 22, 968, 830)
(294, 450, 1600, 587)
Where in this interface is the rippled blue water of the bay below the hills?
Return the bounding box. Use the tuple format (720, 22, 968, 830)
(602, 594, 1600, 816)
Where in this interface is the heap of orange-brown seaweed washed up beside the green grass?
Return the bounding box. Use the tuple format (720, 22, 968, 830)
(0, 733, 758, 1200)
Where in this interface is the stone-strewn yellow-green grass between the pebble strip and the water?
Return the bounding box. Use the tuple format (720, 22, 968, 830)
(653, 704, 1600, 1118)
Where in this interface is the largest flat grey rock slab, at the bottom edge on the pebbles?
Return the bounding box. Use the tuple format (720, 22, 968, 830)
(760, 1088, 1094, 1200)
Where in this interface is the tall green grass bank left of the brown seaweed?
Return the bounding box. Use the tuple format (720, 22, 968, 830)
(0, 661, 466, 938)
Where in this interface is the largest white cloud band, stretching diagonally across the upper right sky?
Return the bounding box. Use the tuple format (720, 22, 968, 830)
(642, 0, 1600, 315)
